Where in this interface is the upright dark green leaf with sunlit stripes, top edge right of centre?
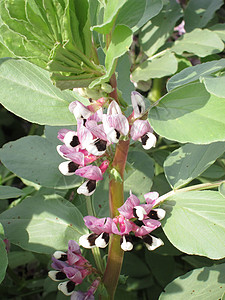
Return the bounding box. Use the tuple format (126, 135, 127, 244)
(140, 0, 182, 56)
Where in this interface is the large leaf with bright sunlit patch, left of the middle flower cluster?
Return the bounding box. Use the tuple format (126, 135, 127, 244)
(0, 195, 87, 254)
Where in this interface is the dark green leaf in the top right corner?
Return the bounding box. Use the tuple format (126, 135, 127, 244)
(184, 0, 223, 32)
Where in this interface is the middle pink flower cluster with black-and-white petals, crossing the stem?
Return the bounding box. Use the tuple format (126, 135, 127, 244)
(79, 192, 165, 251)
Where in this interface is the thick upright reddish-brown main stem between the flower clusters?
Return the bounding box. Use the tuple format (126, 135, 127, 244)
(103, 140, 130, 299)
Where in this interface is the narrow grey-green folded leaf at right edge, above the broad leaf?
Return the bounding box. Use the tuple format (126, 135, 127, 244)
(167, 58, 225, 91)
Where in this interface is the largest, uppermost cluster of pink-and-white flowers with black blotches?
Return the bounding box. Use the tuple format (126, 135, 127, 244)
(57, 92, 156, 196)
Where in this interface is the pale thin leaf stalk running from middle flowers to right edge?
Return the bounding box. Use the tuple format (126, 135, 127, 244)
(157, 180, 225, 203)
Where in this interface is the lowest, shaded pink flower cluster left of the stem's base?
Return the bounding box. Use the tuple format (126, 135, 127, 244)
(48, 240, 100, 300)
